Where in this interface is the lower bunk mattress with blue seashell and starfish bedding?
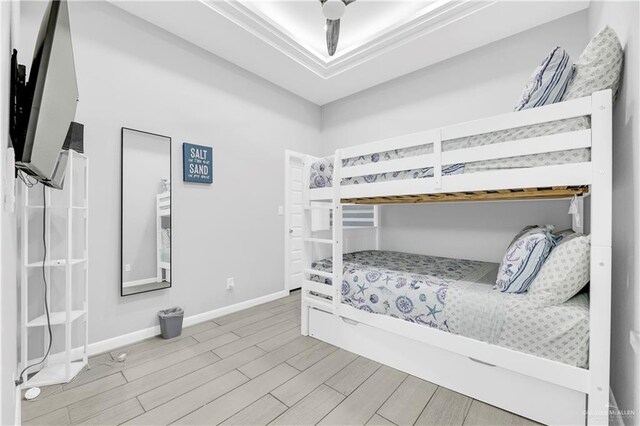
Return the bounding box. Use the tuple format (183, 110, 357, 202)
(311, 250, 589, 368)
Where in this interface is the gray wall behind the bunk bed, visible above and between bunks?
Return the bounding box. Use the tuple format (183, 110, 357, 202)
(322, 12, 588, 262)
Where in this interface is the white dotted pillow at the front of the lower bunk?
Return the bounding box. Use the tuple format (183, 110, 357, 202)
(528, 234, 591, 306)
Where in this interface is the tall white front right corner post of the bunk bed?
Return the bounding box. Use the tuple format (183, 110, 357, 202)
(587, 90, 612, 425)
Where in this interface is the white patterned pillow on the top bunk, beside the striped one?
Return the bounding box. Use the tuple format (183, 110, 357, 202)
(563, 26, 624, 101)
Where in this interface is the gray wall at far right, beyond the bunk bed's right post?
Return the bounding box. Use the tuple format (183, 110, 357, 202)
(589, 1, 640, 425)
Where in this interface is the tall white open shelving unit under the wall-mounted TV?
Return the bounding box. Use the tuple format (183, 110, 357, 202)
(19, 151, 89, 387)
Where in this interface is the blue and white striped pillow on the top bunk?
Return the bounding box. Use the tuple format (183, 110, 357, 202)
(514, 47, 576, 111)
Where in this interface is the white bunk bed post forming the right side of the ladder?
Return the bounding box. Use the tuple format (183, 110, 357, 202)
(331, 149, 343, 315)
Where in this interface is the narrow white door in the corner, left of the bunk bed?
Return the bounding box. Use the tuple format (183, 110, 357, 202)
(284, 150, 305, 290)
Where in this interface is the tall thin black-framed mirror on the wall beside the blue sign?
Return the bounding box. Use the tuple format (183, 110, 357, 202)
(120, 127, 171, 296)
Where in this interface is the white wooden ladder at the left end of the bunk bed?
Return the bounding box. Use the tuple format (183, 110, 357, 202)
(301, 153, 343, 335)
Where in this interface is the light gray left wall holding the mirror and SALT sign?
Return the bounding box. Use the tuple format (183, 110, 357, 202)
(21, 2, 321, 342)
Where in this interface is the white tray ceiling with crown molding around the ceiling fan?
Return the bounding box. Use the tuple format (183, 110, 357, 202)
(111, 0, 589, 105)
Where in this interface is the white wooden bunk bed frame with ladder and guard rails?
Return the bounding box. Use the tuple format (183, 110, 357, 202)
(301, 90, 612, 425)
